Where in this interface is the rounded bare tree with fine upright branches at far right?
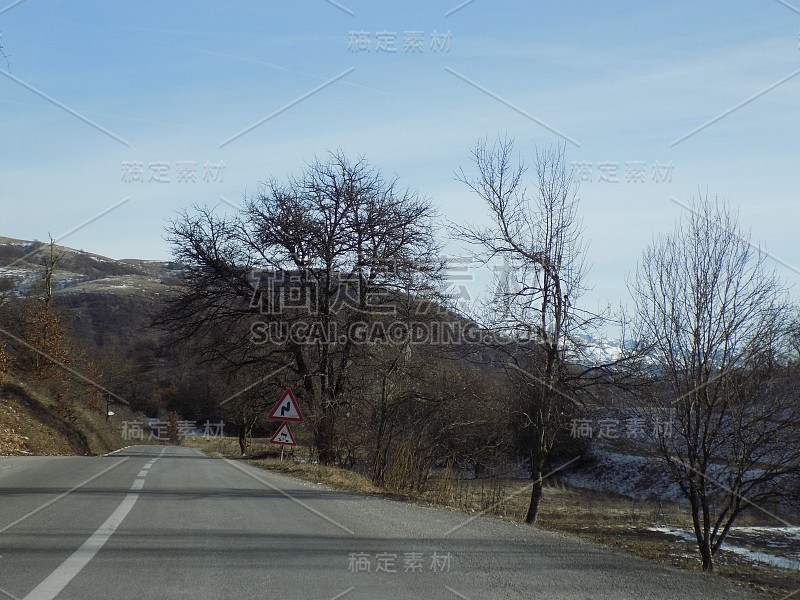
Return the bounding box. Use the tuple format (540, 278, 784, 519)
(630, 197, 800, 571)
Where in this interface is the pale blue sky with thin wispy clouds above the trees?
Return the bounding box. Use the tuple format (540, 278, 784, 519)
(0, 0, 800, 318)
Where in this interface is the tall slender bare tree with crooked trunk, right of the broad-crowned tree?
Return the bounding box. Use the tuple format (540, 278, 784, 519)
(453, 140, 597, 524)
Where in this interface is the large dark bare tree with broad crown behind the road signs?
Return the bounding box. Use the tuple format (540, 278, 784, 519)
(161, 152, 439, 463)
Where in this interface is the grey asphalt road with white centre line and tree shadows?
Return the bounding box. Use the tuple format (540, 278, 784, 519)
(0, 446, 764, 600)
